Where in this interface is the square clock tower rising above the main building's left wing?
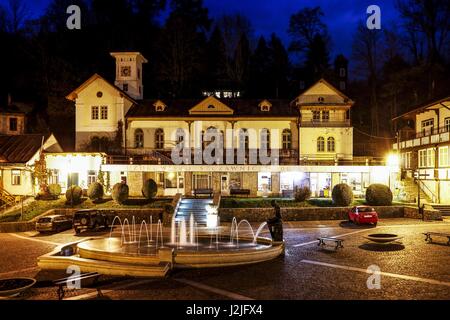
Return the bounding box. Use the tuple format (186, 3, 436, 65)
(111, 52, 148, 100)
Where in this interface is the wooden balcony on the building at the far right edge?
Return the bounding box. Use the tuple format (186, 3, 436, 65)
(393, 125, 450, 150)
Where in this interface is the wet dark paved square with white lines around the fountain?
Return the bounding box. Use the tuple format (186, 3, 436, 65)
(0, 218, 450, 300)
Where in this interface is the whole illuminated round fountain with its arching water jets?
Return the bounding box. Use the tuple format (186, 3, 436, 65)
(38, 215, 284, 276)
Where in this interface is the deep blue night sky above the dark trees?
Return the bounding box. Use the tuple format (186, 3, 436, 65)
(0, 0, 398, 56)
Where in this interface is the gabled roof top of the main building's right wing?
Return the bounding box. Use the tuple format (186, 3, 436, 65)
(295, 79, 354, 106)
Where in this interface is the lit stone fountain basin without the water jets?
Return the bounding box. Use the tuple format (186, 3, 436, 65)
(38, 236, 284, 277)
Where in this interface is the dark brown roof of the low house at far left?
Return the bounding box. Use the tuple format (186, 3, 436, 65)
(0, 134, 56, 163)
